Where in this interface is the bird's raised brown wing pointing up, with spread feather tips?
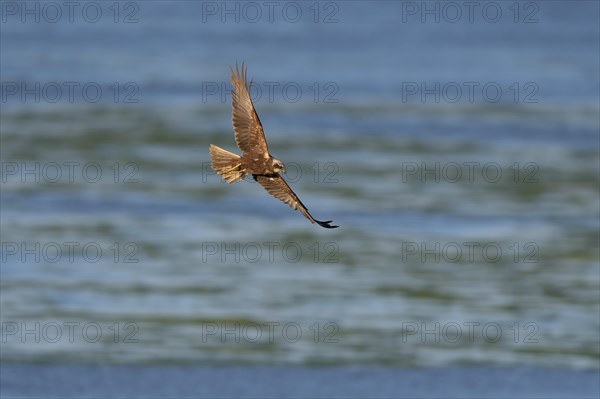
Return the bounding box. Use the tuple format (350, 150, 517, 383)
(229, 64, 269, 158)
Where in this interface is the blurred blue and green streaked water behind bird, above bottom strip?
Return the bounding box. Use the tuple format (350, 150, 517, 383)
(0, 1, 600, 369)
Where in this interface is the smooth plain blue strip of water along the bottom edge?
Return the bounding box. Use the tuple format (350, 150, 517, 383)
(1, 364, 599, 398)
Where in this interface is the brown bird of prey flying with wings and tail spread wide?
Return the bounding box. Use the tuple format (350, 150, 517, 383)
(210, 64, 338, 229)
